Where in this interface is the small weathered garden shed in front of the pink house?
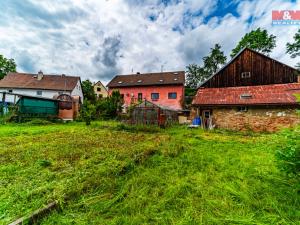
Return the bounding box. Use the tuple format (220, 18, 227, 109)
(130, 100, 178, 126)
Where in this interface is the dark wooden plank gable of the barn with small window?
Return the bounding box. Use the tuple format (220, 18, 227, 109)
(201, 48, 297, 88)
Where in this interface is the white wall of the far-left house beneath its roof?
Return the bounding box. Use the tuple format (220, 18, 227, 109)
(0, 88, 71, 103)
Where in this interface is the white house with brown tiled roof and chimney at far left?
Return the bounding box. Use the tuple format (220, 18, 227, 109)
(0, 71, 83, 103)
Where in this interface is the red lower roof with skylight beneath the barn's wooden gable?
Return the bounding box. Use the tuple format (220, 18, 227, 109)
(192, 83, 300, 106)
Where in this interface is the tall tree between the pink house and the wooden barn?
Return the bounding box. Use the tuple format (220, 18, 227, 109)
(186, 44, 227, 88)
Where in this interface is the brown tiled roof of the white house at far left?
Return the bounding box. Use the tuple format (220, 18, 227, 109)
(0, 73, 80, 91)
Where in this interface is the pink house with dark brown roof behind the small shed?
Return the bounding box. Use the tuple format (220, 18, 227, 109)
(107, 71, 185, 110)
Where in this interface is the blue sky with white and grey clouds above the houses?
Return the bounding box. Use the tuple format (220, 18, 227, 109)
(0, 0, 300, 83)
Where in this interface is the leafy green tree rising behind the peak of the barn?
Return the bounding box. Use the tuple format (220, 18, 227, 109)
(230, 28, 276, 57)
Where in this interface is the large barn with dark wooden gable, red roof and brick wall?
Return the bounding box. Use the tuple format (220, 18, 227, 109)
(192, 48, 300, 131)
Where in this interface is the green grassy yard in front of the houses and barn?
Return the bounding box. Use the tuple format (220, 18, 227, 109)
(0, 122, 300, 225)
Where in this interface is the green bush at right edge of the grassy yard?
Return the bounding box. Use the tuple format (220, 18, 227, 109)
(276, 130, 300, 175)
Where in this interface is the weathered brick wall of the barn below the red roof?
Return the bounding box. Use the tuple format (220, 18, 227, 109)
(213, 108, 300, 132)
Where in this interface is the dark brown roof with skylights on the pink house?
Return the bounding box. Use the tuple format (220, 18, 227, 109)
(107, 71, 185, 88)
